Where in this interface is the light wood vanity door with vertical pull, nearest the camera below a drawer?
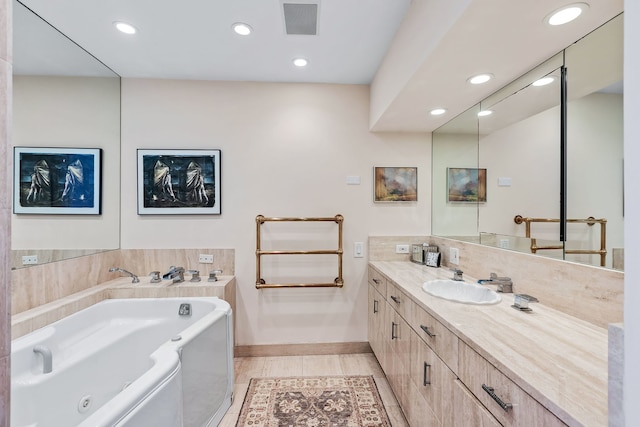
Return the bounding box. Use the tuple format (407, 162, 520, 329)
(410, 332, 456, 426)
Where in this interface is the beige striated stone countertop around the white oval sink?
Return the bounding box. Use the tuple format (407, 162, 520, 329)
(369, 261, 608, 426)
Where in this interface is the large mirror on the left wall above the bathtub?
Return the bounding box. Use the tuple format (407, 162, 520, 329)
(11, 1, 120, 269)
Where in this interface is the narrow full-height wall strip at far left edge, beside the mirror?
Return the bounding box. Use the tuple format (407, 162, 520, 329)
(0, 0, 12, 427)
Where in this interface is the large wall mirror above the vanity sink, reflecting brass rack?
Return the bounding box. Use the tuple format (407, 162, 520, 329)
(432, 15, 624, 270)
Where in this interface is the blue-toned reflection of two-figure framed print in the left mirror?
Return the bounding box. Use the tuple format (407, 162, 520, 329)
(13, 147, 102, 215)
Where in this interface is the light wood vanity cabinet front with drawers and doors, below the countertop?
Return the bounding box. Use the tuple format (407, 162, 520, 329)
(368, 267, 565, 427)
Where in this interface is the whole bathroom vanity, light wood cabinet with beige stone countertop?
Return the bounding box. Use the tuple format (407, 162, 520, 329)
(368, 261, 608, 426)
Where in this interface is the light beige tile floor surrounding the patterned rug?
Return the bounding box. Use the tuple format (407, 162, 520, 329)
(219, 353, 409, 427)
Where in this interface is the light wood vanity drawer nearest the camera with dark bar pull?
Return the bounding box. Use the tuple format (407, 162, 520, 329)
(458, 342, 565, 427)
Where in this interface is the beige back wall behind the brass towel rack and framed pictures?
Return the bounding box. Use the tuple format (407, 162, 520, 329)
(122, 79, 431, 345)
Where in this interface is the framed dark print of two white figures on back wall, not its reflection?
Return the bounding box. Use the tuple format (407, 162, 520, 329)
(138, 149, 221, 215)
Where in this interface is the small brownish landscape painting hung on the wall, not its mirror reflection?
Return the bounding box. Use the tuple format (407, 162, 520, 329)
(373, 166, 418, 202)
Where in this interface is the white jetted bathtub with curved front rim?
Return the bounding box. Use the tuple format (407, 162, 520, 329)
(11, 297, 233, 427)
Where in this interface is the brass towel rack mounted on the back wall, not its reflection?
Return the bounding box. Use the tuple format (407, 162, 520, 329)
(256, 214, 344, 289)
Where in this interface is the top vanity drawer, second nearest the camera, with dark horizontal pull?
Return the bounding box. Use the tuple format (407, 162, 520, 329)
(409, 301, 458, 372)
